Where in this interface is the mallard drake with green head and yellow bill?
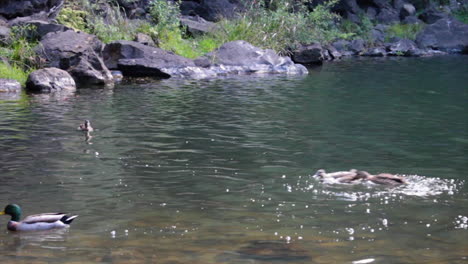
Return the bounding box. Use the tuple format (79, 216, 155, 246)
(0, 204, 78, 231)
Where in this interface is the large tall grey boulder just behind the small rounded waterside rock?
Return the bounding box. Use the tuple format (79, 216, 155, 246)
(36, 30, 112, 87)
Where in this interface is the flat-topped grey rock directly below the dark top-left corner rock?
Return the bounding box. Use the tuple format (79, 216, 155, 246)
(9, 17, 71, 41)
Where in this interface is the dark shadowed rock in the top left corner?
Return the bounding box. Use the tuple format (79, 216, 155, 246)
(0, 0, 64, 19)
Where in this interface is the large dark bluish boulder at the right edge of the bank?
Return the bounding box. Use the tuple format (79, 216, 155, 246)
(416, 18, 468, 53)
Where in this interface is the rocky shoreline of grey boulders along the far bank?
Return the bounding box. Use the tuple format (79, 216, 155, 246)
(0, 0, 468, 94)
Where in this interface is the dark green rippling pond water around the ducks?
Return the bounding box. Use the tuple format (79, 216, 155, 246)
(0, 56, 468, 264)
